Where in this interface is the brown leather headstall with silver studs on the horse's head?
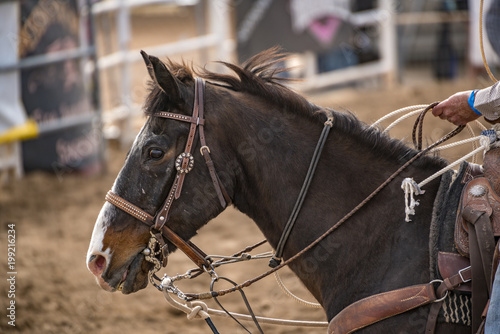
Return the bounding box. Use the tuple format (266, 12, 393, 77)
(106, 78, 231, 278)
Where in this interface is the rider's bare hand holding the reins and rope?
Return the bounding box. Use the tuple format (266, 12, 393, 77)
(432, 90, 480, 125)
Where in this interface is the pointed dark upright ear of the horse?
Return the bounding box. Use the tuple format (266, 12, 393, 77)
(141, 51, 183, 103)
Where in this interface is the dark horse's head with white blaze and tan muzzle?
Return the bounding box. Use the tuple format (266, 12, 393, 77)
(87, 52, 230, 293)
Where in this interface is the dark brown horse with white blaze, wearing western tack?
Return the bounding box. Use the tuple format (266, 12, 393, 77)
(87, 49, 470, 333)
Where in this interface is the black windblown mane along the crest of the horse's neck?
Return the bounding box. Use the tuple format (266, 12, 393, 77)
(144, 48, 445, 165)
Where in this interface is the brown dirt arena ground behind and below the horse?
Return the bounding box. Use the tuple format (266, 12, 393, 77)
(0, 5, 496, 334)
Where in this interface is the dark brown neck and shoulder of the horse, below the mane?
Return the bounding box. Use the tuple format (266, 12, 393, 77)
(225, 108, 444, 313)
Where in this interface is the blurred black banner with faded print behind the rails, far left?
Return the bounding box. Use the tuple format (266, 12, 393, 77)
(18, 0, 102, 174)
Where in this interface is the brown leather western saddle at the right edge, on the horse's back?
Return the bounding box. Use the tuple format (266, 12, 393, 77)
(438, 148, 500, 333)
